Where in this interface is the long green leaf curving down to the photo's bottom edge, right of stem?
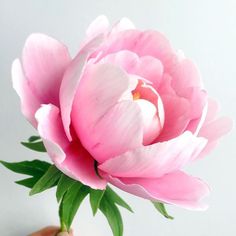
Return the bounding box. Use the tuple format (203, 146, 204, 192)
(99, 192, 123, 236)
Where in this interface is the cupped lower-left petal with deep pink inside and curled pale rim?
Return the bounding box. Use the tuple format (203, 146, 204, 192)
(36, 105, 106, 189)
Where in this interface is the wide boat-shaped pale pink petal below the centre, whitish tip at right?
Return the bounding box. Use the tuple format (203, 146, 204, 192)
(99, 132, 207, 178)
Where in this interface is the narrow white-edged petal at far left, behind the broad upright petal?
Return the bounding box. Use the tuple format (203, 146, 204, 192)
(12, 59, 41, 128)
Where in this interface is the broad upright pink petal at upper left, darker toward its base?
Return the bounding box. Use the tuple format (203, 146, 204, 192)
(22, 34, 71, 106)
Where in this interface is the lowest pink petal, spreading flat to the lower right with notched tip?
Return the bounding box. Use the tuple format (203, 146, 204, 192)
(107, 171, 209, 210)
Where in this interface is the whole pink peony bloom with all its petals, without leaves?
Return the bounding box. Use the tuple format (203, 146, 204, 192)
(12, 16, 232, 209)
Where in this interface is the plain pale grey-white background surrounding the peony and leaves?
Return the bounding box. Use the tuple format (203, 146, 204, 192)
(0, 0, 236, 236)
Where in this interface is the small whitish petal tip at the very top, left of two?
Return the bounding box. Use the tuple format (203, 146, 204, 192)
(86, 15, 110, 39)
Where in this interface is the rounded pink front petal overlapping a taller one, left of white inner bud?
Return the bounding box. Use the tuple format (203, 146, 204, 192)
(72, 98, 143, 163)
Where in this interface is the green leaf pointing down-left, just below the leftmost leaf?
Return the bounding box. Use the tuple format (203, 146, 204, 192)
(30, 165, 61, 196)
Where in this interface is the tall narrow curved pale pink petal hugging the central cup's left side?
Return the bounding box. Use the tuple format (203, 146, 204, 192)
(59, 35, 104, 141)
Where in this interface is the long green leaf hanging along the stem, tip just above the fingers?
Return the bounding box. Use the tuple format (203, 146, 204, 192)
(59, 182, 89, 231)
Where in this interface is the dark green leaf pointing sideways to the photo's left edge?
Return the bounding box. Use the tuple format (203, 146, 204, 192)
(0, 160, 51, 176)
